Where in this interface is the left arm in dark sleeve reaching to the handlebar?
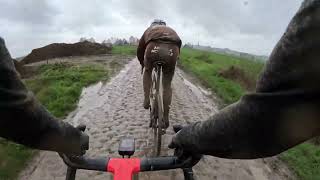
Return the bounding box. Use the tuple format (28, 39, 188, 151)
(0, 37, 87, 154)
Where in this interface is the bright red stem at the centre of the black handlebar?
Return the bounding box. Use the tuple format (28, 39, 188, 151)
(106, 158, 140, 180)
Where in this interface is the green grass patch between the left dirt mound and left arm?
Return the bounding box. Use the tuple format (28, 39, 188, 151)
(26, 64, 108, 118)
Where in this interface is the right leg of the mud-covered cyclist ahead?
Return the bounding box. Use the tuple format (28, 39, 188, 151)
(162, 44, 179, 128)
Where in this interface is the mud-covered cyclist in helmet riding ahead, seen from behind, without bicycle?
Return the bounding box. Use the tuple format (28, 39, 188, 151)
(137, 20, 182, 129)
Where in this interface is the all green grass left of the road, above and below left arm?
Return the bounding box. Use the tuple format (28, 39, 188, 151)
(0, 64, 109, 180)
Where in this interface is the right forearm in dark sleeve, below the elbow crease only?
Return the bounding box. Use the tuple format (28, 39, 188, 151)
(174, 92, 320, 159)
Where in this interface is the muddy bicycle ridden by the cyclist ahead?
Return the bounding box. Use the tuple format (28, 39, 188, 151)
(150, 61, 165, 156)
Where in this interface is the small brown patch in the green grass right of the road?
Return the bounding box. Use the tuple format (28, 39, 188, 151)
(219, 66, 256, 90)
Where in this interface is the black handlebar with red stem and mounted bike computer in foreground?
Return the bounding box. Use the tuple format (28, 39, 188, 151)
(59, 138, 194, 180)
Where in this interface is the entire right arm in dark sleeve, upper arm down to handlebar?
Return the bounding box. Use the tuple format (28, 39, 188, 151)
(173, 0, 320, 158)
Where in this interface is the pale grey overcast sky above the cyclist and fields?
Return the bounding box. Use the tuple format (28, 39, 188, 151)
(0, 0, 302, 57)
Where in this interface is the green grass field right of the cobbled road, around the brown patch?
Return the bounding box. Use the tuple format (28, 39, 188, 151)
(178, 48, 264, 104)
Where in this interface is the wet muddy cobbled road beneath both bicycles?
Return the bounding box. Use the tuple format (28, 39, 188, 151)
(20, 60, 293, 180)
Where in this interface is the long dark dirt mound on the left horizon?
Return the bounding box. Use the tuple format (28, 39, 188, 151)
(21, 41, 111, 64)
